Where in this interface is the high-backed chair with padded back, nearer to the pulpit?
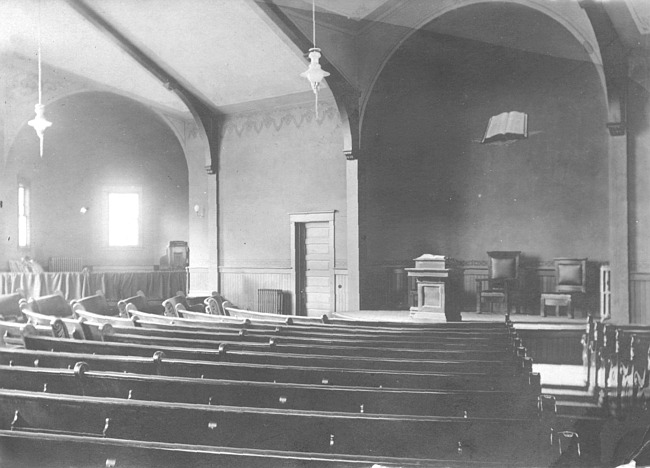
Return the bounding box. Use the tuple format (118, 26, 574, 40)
(476, 251, 521, 313)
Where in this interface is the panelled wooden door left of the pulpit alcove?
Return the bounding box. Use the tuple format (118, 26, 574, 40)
(295, 221, 334, 316)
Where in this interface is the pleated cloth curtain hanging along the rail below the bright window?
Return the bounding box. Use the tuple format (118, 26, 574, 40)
(0, 271, 187, 302)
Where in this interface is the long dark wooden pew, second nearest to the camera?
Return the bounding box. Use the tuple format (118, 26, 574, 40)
(0, 390, 555, 466)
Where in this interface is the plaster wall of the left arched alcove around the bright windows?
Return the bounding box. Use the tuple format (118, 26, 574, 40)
(0, 93, 188, 267)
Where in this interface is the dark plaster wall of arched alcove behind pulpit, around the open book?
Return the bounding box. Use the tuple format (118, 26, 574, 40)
(360, 36, 608, 296)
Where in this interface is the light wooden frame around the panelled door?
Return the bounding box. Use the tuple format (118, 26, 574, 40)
(289, 210, 336, 315)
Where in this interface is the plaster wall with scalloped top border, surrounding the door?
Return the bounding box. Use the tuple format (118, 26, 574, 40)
(219, 102, 347, 268)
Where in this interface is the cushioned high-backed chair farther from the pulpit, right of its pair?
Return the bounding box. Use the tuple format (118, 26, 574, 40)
(539, 258, 587, 318)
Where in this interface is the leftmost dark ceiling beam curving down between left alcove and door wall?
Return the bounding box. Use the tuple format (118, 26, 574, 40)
(66, 0, 223, 174)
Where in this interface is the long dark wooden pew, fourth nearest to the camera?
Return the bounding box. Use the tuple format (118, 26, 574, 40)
(0, 348, 541, 395)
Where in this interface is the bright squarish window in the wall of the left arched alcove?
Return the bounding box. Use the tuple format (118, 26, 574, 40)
(108, 192, 140, 247)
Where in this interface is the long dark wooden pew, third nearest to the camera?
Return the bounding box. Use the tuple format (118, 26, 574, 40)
(0, 362, 539, 418)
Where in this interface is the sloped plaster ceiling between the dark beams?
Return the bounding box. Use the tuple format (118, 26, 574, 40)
(0, 0, 650, 116)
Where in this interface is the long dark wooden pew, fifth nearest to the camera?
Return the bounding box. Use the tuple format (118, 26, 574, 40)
(24, 336, 532, 375)
